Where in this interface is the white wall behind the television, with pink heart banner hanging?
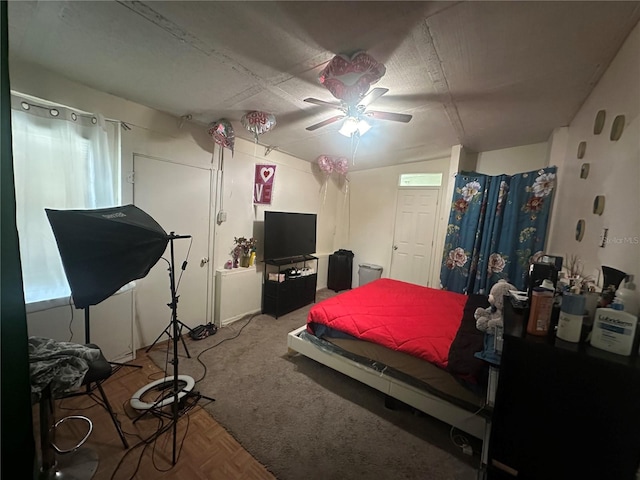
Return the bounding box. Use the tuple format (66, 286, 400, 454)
(213, 135, 338, 325)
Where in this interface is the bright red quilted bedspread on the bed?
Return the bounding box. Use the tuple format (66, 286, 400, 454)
(307, 278, 469, 369)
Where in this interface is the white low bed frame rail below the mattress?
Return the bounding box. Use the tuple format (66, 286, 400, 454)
(287, 325, 496, 452)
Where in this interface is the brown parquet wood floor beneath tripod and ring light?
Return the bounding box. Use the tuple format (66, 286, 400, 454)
(33, 349, 275, 480)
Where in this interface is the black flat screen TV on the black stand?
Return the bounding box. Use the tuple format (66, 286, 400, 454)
(264, 211, 316, 260)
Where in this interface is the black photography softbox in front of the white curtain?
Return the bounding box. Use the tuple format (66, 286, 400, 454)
(45, 205, 169, 308)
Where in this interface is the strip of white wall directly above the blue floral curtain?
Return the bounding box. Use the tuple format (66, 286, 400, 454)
(476, 142, 549, 175)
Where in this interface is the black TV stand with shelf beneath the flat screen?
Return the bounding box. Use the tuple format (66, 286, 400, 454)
(262, 255, 318, 318)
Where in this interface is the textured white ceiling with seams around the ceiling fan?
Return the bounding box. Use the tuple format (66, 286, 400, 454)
(9, 1, 640, 168)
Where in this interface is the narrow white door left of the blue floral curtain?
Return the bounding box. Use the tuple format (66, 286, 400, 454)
(390, 188, 440, 286)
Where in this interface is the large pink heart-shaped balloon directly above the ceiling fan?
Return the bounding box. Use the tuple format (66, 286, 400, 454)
(319, 52, 386, 105)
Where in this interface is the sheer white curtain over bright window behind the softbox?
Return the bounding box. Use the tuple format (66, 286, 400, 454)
(11, 95, 120, 304)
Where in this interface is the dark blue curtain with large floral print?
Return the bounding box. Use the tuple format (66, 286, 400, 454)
(440, 167, 556, 294)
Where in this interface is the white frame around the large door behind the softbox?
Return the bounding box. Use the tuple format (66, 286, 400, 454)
(131, 151, 220, 342)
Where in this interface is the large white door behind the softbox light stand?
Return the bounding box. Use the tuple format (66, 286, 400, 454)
(133, 154, 213, 347)
